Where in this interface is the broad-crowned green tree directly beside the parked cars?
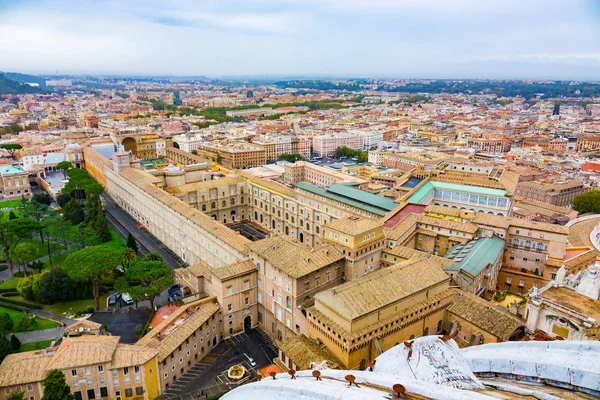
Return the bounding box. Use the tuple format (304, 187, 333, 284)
(115, 261, 174, 308)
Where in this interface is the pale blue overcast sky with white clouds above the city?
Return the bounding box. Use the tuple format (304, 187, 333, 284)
(0, 0, 600, 79)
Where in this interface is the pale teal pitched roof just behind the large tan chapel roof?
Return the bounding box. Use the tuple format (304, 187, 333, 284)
(444, 237, 504, 276)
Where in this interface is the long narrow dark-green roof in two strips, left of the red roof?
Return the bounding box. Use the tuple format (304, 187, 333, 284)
(296, 182, 398, 216)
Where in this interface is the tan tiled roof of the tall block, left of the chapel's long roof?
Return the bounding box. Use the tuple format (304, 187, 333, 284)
(248, 236, 344, 278)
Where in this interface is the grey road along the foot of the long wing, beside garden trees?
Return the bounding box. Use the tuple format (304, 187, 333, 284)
(102, 194, 184, 269)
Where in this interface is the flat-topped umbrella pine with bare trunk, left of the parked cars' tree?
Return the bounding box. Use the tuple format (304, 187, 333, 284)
(62, 246, 122, 310)
